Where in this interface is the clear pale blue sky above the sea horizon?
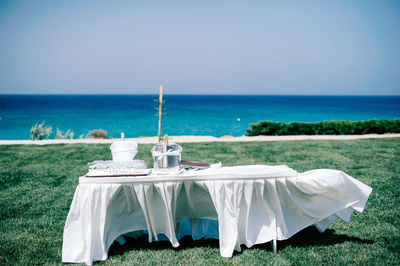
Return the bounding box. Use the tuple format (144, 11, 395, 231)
(0, 0, 400, 95)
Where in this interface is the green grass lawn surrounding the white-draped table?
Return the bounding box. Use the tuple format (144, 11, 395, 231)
(0, 138, 400, 265)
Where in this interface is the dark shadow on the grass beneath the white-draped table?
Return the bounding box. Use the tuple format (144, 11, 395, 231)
(108, 226, 374, 257)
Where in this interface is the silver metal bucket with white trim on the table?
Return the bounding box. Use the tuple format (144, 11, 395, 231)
(151, 143, 182, 170)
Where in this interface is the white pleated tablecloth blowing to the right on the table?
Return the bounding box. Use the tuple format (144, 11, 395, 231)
(62, 165, 372, 265)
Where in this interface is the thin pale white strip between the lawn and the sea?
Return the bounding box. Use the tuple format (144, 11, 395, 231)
(0, 134, 400, 145)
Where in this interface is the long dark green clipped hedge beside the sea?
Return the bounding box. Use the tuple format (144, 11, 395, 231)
(246, 119, 400, 136)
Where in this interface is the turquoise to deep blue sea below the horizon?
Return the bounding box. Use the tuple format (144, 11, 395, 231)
(0, 95, 400, 139)
